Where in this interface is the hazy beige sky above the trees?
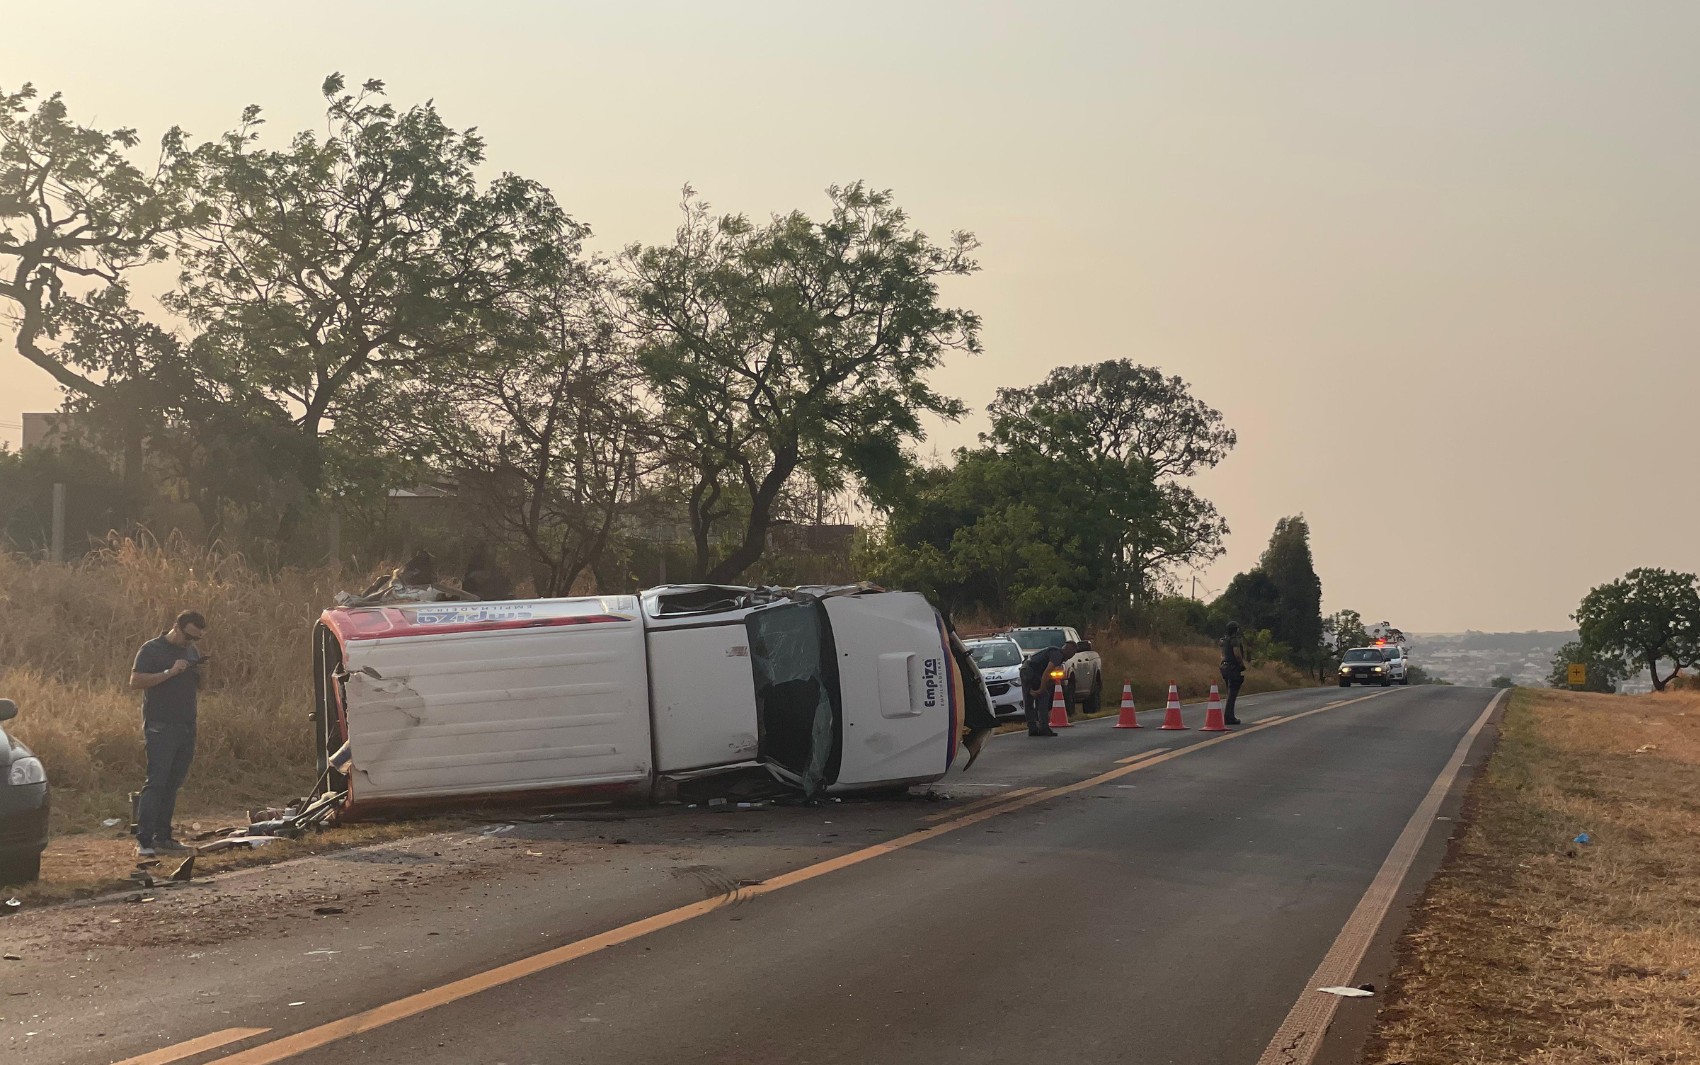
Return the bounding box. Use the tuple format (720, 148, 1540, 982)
(0, 0, 1700, 631)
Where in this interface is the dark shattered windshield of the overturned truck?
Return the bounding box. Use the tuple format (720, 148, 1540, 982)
(746, 602, 843, 796)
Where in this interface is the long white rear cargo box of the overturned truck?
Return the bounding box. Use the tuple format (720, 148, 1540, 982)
(340, 597, 651, 803)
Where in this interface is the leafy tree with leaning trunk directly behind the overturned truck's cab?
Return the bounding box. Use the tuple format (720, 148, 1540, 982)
(624, 182, 979, 580)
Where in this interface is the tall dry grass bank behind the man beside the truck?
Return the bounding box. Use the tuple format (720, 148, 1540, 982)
(0, 541, 343, 834)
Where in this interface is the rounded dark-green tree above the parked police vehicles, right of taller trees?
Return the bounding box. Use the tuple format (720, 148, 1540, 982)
(986, 359, 1236, 606)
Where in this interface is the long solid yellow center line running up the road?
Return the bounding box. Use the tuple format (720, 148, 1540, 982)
(198, 692, 1387, 1065)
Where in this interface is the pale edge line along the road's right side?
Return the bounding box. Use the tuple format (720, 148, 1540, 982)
(1258, 691, 1505, 1065)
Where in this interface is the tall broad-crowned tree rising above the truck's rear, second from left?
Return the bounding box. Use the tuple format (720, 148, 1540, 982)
(167, 75, 585, 497)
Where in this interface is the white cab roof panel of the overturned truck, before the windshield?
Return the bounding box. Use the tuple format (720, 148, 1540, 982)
(649, 611, 757, 772)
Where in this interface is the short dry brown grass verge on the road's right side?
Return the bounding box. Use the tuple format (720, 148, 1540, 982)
(1363, 689, 1700, 1065)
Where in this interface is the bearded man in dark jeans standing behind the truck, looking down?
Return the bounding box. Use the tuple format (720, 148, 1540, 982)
(129, 611, 207, 857)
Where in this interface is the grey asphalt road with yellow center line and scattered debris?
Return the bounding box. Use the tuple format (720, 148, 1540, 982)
(0, 687, 1493, 1065)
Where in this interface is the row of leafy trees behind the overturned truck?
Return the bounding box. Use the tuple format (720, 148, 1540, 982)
(0, 75, 1234, 618)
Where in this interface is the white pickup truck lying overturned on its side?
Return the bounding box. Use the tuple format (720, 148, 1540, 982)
(315, 585, 964, 818)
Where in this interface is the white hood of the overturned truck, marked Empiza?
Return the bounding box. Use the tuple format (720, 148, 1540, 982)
(825, 592, 962, 788)
